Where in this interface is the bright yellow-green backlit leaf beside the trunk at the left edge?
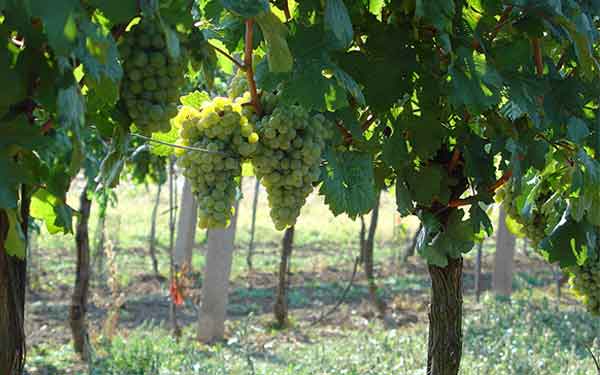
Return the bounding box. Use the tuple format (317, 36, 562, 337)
(30, 189, 73, 234)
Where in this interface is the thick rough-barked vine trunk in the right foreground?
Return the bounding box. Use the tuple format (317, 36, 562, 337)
(426, 258, 463, 375)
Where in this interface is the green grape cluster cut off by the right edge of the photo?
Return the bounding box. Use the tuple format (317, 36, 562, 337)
(568, 254, 600, 315)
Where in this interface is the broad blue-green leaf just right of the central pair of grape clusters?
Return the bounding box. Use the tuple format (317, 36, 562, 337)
(319, 150, 376, 219)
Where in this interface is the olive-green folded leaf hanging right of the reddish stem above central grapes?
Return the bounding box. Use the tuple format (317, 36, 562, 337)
(256, 12, 294, 73)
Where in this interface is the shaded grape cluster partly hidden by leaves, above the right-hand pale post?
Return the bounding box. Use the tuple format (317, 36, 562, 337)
(496, 180, 549, 248)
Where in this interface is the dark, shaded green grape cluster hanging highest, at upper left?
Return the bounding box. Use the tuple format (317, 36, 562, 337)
(119, 19, 184, 134)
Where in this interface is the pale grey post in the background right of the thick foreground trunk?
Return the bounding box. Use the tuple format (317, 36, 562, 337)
(492, 207, 516, 297)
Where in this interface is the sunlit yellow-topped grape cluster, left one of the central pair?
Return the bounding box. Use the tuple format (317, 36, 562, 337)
(173, 97, 258, 228)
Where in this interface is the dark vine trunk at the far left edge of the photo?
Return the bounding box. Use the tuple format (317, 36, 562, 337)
(0, 188, 30, 375)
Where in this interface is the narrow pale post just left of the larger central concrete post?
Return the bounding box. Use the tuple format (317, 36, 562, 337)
(173, 178, 198, 272)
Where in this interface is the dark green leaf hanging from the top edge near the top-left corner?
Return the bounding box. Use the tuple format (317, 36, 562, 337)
(31, 0, 79, 56)
